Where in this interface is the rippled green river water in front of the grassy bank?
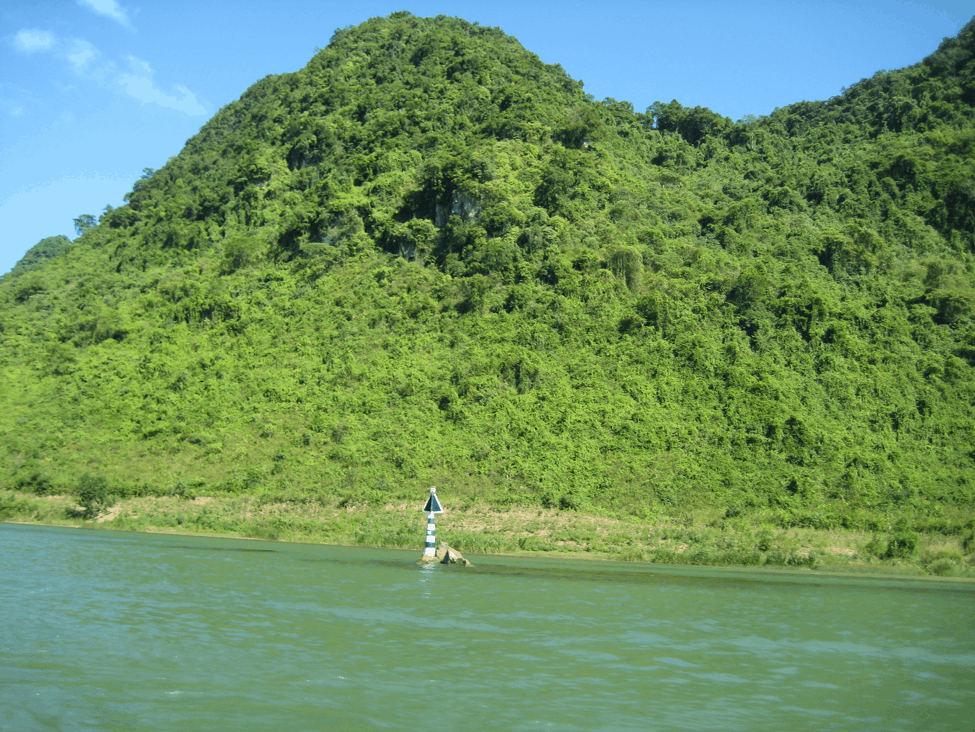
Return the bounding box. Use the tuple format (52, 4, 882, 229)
(0, 522, 975, 732)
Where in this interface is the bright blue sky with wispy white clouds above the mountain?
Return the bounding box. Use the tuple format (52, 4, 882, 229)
(0, 0, 973, 273)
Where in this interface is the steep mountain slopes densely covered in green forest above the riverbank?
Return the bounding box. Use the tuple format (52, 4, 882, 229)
(0, 13, 975, 526)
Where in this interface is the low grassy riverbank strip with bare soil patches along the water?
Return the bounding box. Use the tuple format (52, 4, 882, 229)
(0, 491, 975, 578)
